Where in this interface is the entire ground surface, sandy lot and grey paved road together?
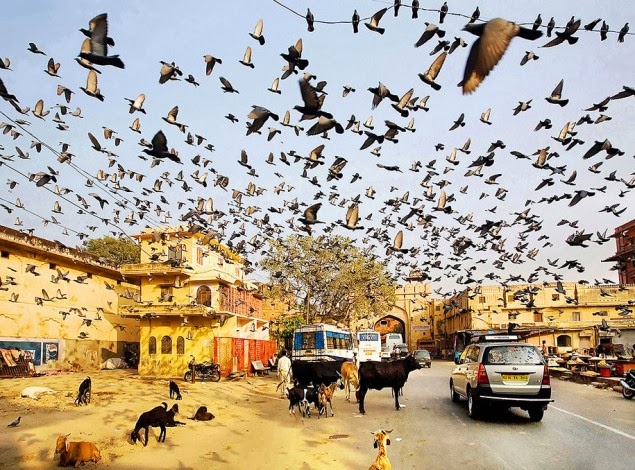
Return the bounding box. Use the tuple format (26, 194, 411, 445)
(0, 361, 635, 470)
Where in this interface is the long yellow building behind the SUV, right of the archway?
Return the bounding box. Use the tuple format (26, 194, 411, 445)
(435, 282, 635, 351)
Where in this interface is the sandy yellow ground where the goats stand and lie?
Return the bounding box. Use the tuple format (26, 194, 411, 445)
(0, 370, 374, 470)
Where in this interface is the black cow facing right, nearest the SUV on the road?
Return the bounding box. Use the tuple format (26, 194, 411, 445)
(358, 354, 421, 414)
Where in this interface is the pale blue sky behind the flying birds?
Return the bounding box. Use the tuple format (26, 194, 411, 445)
(0, 0, 635, 293)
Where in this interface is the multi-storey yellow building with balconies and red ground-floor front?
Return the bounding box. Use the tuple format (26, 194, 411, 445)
(119, 227, 275, 376)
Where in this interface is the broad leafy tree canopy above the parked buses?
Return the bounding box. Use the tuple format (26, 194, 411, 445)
(259, 235, 395, 326)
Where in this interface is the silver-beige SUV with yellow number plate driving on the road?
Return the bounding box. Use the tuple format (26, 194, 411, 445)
(450, 335, 553, 421)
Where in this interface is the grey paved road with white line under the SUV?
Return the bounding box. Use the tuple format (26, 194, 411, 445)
(346, 361, 635, 469)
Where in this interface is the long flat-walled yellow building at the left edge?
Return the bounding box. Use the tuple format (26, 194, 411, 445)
(0, 226, 139, 370)
